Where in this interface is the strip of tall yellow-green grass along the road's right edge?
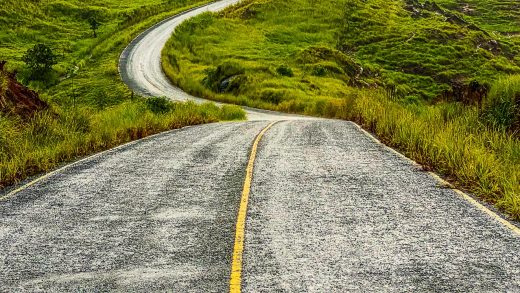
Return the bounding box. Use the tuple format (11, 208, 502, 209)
(341, 91, 520, 220)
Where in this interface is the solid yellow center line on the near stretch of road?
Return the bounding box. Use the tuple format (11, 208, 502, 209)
(229, 121, 278, 293)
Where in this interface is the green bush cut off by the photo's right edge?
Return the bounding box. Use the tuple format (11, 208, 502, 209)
(483, 75, 520, 132)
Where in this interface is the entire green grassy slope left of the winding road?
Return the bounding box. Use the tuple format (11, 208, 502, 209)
(0, 0, 245, 188)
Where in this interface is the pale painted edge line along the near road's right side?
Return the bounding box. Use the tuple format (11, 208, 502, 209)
(354, 123, 520, 235)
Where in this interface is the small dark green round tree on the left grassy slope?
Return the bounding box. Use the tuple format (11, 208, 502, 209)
(23, 44, 58, 79)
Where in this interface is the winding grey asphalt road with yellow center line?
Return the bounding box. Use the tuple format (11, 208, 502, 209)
(0, 1, 520, 292)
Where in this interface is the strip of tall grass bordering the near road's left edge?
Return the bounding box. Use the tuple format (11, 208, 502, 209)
(0, 98, 245, 186)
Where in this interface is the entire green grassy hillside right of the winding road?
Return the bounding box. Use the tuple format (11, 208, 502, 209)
(163, 0, 520, 220)
